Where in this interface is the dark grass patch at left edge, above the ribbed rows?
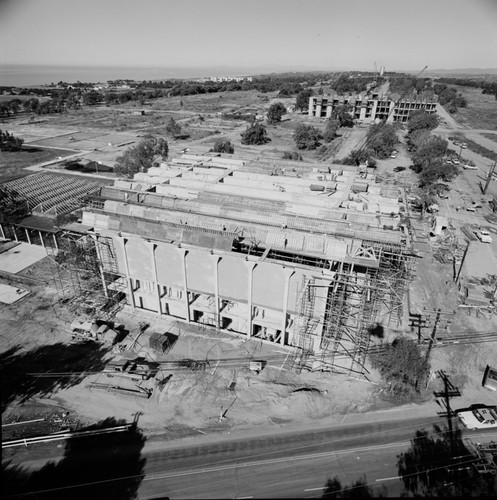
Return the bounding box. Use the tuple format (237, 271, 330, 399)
(0, 147, 71, 183)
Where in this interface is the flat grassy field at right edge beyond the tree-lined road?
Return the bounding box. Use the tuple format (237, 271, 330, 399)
(453, 86, 497, 130)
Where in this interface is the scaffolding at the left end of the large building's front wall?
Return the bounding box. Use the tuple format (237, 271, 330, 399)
(46, 231, 126, 320)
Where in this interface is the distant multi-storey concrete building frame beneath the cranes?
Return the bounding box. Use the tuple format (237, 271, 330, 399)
(309, 93, 437, 123)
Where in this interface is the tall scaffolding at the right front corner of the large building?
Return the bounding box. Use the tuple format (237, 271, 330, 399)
(296, 241, 415, 379)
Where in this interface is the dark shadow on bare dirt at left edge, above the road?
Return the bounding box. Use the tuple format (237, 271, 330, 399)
(0, 343, 109, 412)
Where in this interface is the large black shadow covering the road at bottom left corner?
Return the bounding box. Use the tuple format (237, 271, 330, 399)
(2, 418, 146, 500)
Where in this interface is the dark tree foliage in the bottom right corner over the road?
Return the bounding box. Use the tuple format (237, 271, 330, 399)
(397, 425, 497, 498)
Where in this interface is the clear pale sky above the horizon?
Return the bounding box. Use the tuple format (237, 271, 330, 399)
(0, 0, 497, 71)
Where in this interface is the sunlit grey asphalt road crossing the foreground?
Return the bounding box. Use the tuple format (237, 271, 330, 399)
(7, 416, 497, 500)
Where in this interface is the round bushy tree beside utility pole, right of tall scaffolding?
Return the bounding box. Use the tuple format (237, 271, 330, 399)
(370, 337, 430, 399)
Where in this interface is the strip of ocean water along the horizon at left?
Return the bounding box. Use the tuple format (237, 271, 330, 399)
(0, 65, 260, 87)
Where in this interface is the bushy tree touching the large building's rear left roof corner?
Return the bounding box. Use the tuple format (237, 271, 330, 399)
(114, 136, 169, 179)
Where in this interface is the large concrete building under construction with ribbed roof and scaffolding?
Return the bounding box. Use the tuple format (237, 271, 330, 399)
(80, 155, 413, 374)
